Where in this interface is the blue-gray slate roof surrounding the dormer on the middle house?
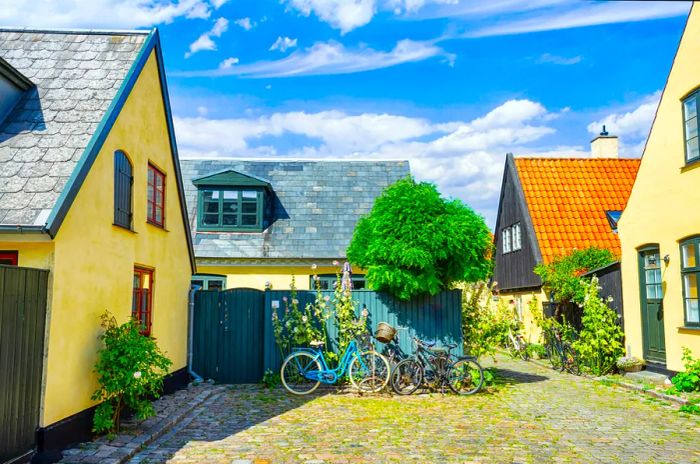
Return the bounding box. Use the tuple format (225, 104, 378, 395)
(180, 159, 409, 258)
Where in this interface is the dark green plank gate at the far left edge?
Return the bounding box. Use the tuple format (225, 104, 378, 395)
(0, 265, 49, 462)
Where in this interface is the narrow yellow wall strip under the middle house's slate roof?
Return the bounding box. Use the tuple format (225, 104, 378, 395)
(197, 263, 364, 290)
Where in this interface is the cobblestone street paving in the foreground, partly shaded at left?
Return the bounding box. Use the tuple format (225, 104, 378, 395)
(130, 358, 700, 464)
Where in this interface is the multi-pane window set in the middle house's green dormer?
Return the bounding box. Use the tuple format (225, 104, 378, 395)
(198, 188, 262, 231)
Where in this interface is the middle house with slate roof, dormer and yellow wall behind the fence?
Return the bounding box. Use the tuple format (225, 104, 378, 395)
(181, 158, 410, 290)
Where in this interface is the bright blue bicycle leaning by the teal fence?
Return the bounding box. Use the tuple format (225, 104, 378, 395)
(280, 340, 391, 395)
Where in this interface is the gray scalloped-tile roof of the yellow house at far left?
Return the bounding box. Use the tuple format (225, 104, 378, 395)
(0, 29, 148, 225)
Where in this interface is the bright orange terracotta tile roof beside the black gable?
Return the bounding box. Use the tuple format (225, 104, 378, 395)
(515, 158, 640, 263)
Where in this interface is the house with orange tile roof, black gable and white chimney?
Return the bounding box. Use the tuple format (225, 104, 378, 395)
(494, 143, 639, 343)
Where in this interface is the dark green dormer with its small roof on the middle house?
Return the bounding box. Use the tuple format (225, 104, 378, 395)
(193, 171, 270, 232)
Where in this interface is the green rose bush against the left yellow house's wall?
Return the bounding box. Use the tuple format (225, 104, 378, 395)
(92, 312, 172, 433)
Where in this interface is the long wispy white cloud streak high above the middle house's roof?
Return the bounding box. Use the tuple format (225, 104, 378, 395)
(178, 39, 454, 78)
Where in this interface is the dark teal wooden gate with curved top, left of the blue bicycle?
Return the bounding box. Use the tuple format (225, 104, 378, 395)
(192, 288, 265, 383)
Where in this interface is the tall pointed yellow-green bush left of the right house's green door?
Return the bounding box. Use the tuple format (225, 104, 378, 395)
(573, 277, 624, 376)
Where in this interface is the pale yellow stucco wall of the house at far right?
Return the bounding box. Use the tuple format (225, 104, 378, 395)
(618, 5, 700, 370)
